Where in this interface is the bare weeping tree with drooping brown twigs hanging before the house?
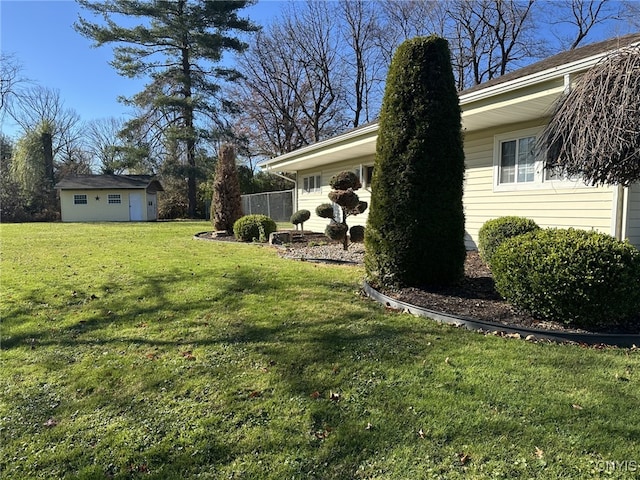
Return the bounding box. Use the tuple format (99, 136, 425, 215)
(540, 45, 640, 185)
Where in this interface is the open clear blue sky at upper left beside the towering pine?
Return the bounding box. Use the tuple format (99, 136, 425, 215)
(0, 0, 284, 139)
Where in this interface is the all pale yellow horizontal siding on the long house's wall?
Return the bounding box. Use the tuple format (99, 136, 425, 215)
(298, 121, 616, 249)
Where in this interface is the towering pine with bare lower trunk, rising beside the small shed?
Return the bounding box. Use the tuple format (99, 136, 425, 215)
(75, 0, 257, 217)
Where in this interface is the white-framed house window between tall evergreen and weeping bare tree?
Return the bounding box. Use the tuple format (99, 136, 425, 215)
(499, 136, 536, 184)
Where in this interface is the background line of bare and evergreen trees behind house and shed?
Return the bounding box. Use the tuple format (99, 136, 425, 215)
(0, 0, 640, 221)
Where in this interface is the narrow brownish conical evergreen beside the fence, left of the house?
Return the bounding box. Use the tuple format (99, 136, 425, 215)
(212, 144, 242, 233)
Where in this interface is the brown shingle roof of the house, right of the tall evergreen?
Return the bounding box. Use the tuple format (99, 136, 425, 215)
(460, 32, 640, 95)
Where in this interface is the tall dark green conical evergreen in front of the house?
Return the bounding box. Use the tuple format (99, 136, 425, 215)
(365, 36, 466, 286)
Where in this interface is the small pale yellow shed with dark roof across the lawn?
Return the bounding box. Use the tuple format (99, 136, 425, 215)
(56, 175, 164, 222)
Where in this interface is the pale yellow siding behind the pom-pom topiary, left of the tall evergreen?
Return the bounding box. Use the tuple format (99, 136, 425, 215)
(297, 156, 374, 232)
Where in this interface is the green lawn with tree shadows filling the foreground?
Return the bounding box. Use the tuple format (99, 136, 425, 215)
(0, 222, 640, 479)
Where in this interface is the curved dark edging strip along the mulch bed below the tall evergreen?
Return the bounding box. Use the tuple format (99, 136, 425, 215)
(363, 282, 640, 348)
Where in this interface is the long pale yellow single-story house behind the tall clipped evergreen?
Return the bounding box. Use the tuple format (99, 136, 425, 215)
(261, 33, 640, 249)
